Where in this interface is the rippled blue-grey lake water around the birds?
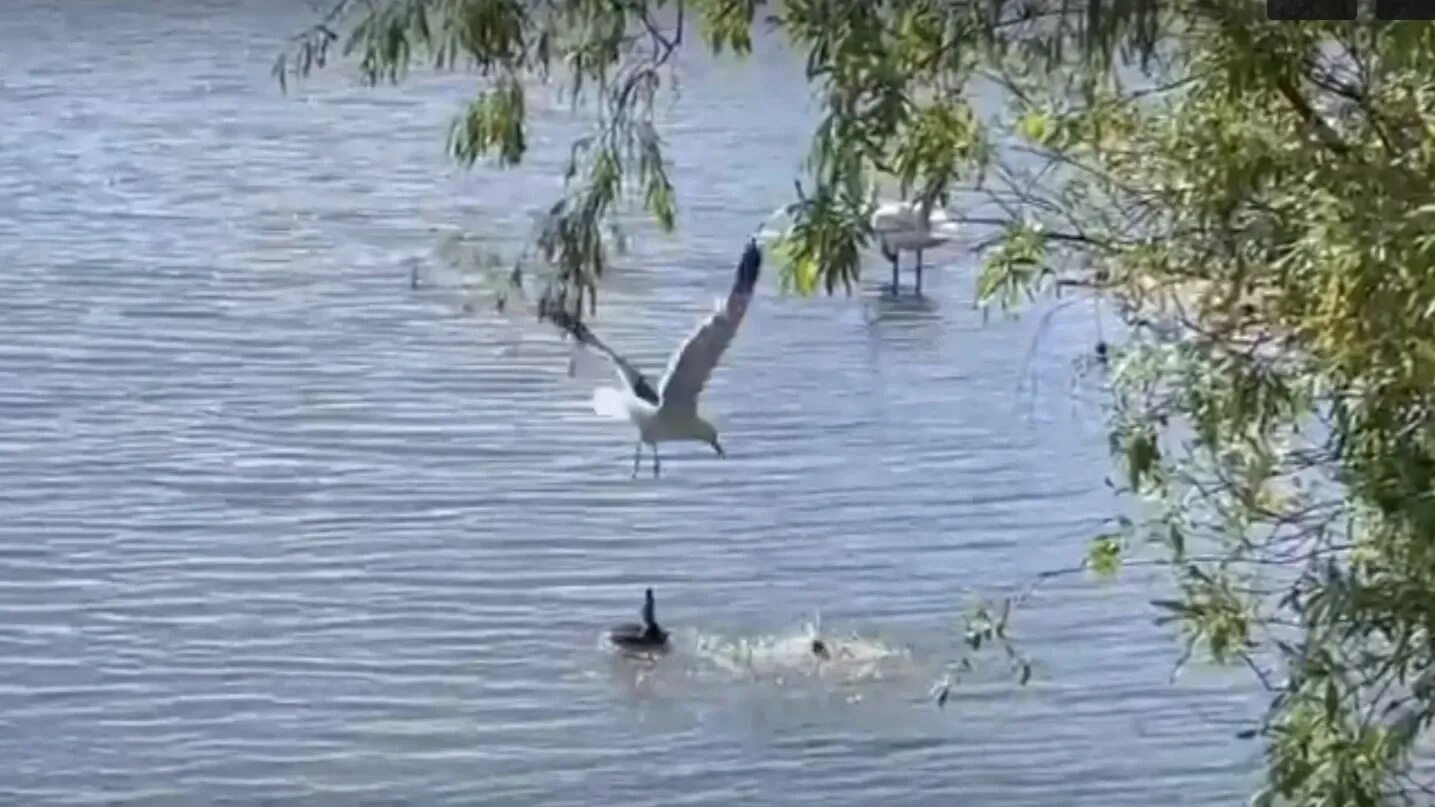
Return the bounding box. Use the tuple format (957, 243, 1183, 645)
(0, 0, 1260, 807)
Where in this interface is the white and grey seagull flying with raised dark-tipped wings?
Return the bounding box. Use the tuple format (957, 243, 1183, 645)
(552, 240, 762, 478)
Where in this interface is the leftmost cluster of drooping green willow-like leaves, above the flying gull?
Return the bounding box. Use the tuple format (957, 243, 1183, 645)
(274, 0, 694, 316)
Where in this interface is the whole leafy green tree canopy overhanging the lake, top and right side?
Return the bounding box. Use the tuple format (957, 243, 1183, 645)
(277, 0, 1435, 806)
